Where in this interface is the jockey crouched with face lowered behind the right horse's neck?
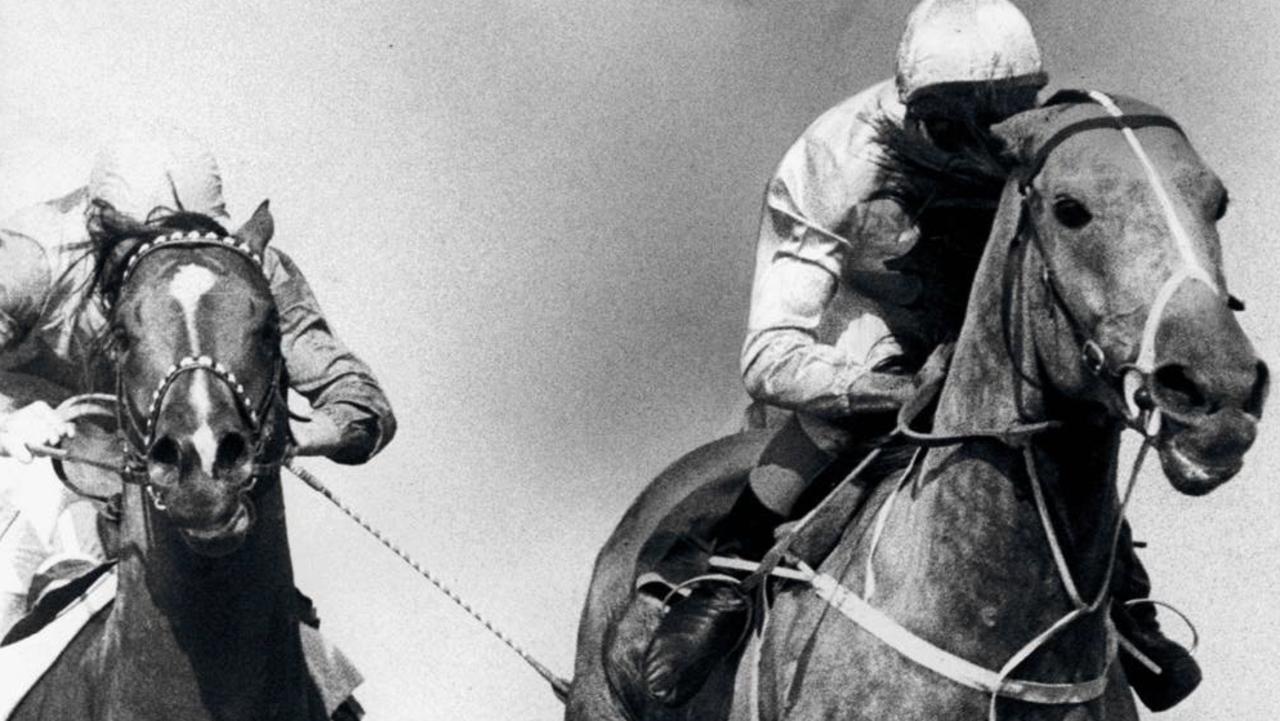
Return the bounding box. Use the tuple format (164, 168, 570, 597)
(645, 0, 1199, 709)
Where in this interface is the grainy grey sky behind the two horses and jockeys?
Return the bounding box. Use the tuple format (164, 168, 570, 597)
(0, 0, 1280, 721)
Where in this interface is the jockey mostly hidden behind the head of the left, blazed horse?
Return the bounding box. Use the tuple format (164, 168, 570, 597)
(0, 128, 396, 636)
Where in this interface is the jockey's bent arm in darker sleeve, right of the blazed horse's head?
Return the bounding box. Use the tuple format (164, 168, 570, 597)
(266, 248, 396, 464)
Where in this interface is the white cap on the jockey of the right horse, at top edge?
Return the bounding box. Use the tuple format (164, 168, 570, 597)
(896, 0, 1046, 102)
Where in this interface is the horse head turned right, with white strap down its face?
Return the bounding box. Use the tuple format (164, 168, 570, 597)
(993, 91, 1268, 494)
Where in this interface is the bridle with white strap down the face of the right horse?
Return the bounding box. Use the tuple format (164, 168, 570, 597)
(1004, 91, 1223, 438)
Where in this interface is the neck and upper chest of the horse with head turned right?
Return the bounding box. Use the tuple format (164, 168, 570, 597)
(882, 203, 1119, 680)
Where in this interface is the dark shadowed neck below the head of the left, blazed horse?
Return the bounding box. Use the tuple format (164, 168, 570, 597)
(109, 483, 301, 718)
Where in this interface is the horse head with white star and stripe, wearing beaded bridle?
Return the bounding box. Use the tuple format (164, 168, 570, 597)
(97, 202, 287, 556)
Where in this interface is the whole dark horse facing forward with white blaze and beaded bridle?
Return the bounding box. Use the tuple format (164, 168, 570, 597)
(10, 204, 355, 721)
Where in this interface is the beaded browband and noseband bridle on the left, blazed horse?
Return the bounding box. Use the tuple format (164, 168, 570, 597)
(105, 232, 285, 511)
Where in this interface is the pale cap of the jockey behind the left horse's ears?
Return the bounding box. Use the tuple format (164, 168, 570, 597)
(88, 131, 228, 223)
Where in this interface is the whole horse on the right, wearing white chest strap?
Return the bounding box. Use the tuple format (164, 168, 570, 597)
(567, 93, 1267, 721)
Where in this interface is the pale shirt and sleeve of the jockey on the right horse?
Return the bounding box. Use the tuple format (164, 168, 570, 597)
(741, 82, 913, 432)
